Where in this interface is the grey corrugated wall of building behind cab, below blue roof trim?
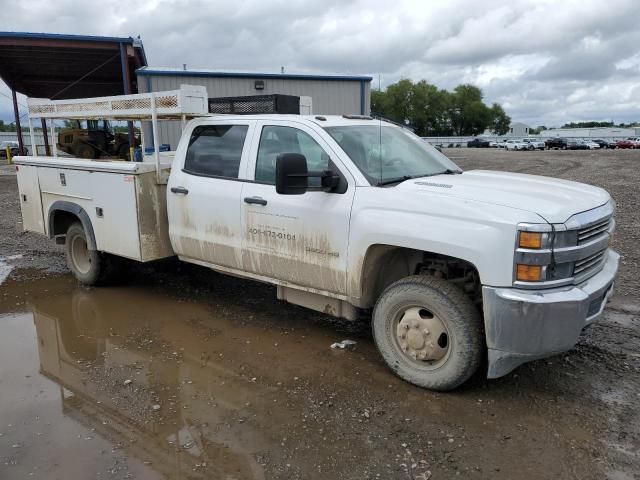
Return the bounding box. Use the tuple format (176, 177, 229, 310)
(138, 75, 371, 149)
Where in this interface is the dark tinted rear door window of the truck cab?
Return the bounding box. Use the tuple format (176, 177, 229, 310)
(184, 125, 249, 178)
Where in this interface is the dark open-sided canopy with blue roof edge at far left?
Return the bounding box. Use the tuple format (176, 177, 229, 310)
(0, 32, 147, 155)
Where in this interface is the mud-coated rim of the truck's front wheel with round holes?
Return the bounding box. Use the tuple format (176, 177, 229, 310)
(393, 305, 451, 370)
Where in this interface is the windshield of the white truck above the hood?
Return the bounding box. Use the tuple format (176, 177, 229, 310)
(325, 122, 461, 185)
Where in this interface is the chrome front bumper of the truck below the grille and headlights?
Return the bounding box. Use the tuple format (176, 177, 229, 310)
(482, 250, 620, 378)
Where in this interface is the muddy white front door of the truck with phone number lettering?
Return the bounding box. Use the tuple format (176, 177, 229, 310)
(241, 120, 355, 294)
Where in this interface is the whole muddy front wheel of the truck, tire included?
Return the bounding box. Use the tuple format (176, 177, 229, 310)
(372, 275, 484, 391)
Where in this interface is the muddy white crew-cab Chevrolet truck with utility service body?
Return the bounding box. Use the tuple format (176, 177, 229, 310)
(15, 88, 619, 390)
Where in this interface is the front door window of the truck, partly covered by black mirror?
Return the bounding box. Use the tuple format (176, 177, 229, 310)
(256, 126, 330, 187)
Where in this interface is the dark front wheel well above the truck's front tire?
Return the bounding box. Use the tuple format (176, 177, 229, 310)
(360, 245, 482, 308)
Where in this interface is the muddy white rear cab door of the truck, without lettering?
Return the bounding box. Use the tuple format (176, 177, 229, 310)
(167, 120, 255, 269)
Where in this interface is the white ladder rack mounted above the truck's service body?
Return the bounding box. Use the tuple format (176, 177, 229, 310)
(27, 85, 209, 182)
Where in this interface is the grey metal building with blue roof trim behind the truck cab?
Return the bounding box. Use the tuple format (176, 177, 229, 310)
(136, 67, 371, 149)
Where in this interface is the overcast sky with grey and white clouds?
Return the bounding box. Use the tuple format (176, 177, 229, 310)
(0, 0, 640, 127)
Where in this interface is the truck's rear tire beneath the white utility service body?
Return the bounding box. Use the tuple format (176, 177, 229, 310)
(65, 222, 118, 285)
